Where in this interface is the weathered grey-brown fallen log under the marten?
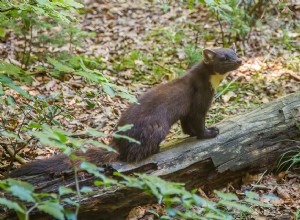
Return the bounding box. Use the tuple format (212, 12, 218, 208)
(2, 92, 300, 219)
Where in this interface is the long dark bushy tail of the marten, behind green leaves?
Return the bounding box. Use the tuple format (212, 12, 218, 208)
(8, 148, 119, 178)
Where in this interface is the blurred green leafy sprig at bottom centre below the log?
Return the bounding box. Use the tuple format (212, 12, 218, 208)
(115, 173, 272, 219)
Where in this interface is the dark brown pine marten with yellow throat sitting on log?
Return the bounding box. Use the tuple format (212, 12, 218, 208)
(10, 48, 242, 177)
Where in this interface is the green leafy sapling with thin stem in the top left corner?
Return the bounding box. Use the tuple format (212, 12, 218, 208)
(0, 0, 83, 69)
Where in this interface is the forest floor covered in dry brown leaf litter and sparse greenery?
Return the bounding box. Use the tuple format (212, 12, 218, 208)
(0, 1, 300, 219)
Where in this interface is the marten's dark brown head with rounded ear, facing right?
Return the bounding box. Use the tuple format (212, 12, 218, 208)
(203, 48, 242, 74)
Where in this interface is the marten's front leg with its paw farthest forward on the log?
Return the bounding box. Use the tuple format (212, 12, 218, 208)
(191, 115, 219, 139)
